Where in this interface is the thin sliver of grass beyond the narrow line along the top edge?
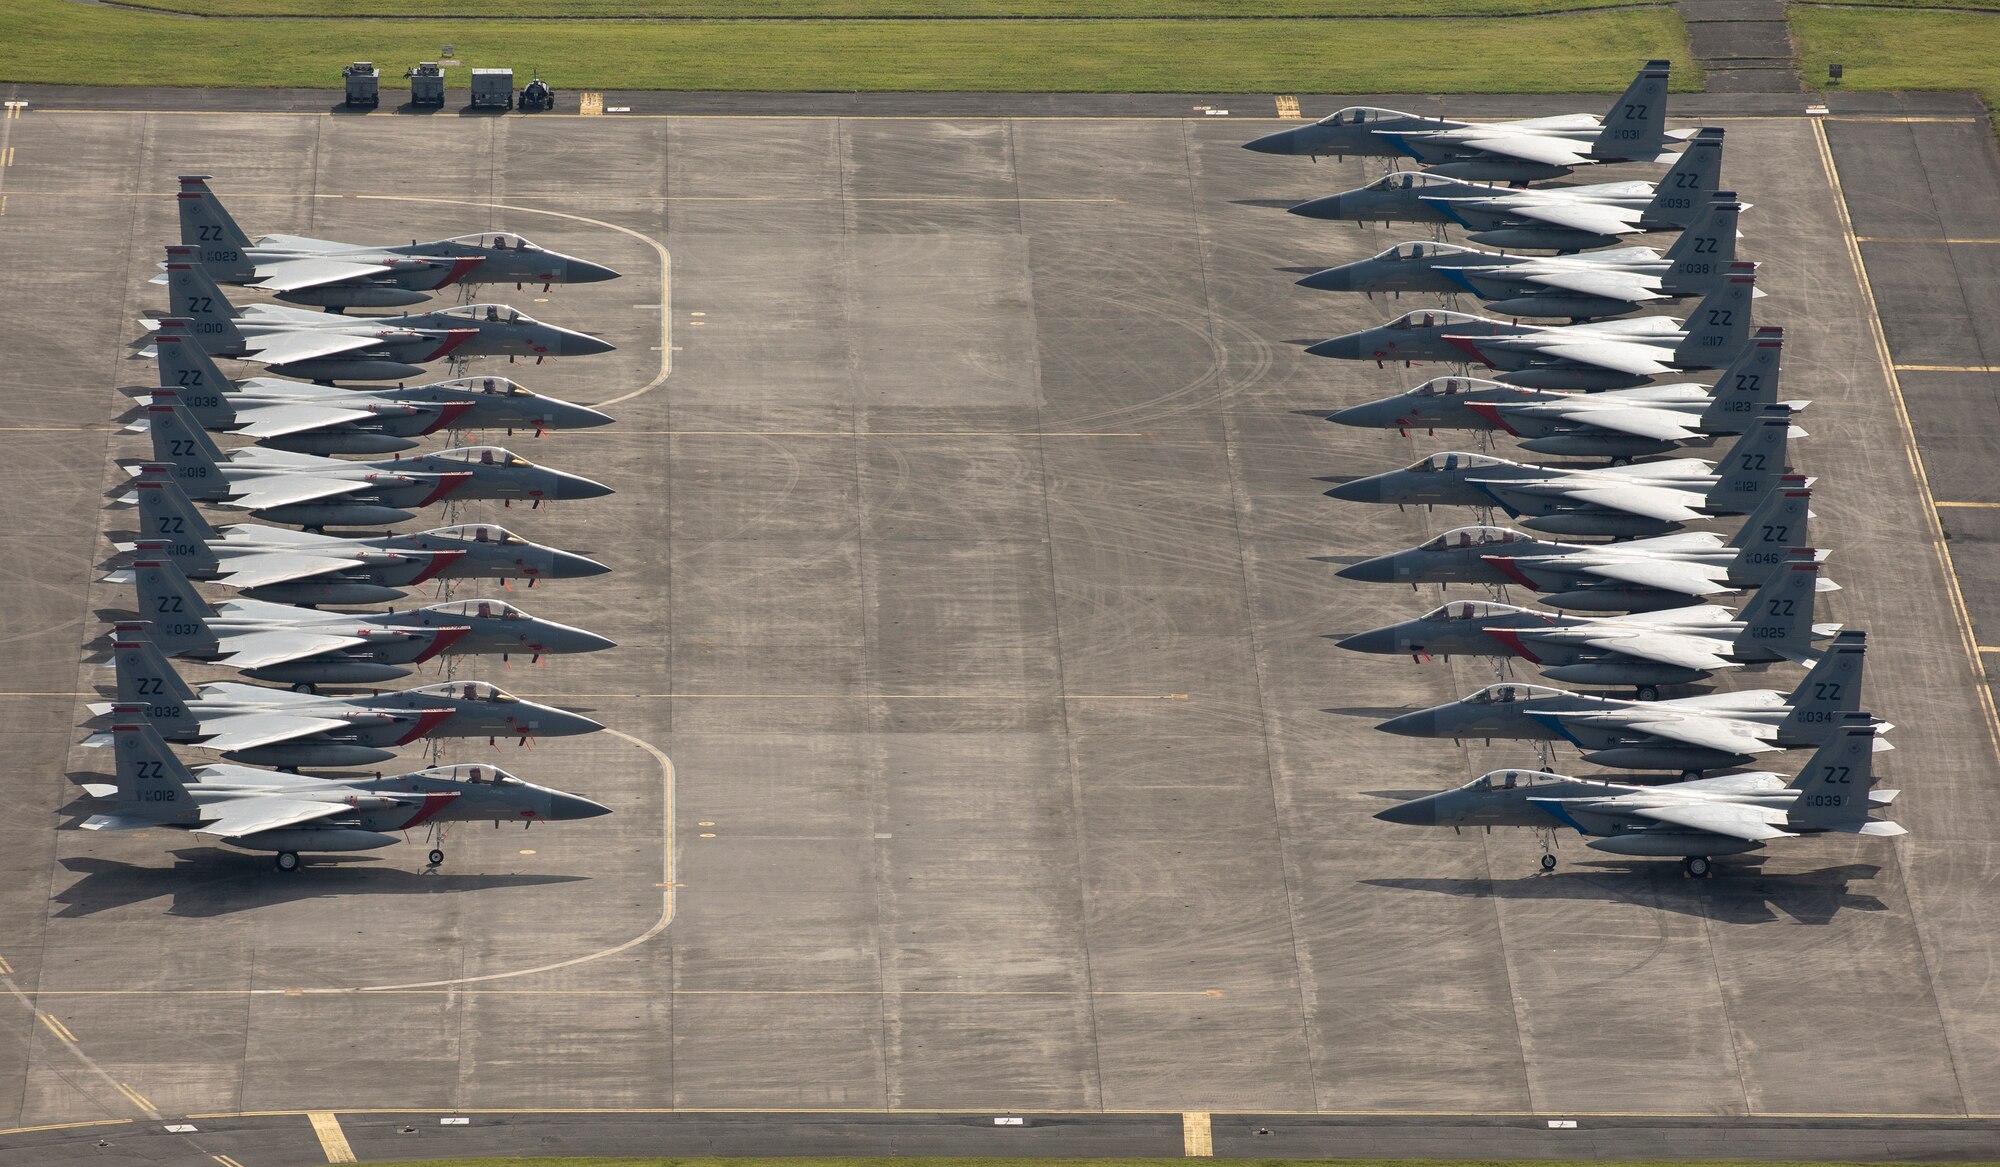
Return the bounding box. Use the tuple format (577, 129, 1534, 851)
(97, 0, 1660, 20)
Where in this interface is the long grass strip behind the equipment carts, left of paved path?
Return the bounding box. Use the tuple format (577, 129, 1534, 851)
(0, 0, 1700, 100)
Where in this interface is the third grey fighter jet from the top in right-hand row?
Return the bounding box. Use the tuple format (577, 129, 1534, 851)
(1298, 190, 1762, 322)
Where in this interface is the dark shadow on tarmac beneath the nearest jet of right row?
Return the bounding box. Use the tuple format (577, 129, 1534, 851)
(1362, 859, 1888, 923)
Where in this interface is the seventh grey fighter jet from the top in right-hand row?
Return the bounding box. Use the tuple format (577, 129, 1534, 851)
(1336, 474, 1840, 611)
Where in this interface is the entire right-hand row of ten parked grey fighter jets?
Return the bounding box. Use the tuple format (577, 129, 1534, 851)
(1246, 62, 1904, 877)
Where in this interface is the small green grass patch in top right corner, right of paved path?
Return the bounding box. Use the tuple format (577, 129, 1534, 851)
(1790, 0, 2000, 108)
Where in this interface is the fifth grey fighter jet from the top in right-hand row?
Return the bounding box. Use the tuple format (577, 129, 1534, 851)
(1326, 328, 1812, 466)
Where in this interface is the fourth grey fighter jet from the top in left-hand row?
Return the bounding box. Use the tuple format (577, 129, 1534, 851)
(146, 392, 612, 528)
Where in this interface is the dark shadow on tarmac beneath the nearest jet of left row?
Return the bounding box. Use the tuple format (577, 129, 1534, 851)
(54, 847, 586, 919)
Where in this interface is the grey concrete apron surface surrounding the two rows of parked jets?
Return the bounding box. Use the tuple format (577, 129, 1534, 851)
(0, 86, 2000, 1165)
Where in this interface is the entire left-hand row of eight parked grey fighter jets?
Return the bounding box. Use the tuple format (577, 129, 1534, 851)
(76, 178, 616, 871)
